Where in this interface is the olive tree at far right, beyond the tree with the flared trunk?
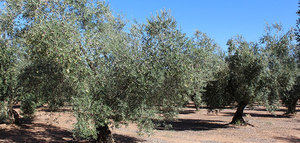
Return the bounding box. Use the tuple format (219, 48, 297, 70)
(261, 24, 299, 114)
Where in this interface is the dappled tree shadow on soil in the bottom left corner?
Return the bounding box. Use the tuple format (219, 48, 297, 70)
(0, 123, 73, 142)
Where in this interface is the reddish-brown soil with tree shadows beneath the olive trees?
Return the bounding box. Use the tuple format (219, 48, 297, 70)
(0, 106, 300, 143)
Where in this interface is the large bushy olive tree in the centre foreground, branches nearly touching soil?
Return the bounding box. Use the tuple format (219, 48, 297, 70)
(74, 7, 197, 142)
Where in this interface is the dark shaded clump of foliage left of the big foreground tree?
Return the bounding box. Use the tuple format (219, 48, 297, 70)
(19, 58, 74, 110)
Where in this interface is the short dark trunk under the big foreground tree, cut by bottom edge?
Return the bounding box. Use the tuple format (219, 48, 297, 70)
(96, 125, 115, 143)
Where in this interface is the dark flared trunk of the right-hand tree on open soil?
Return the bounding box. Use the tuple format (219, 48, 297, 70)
(230, 102, 247, 125)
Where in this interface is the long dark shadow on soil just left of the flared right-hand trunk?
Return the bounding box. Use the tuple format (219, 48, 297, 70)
(155, 119, 230, 131)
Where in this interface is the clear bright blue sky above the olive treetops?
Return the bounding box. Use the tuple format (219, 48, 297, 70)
(108, 0, 300, 50)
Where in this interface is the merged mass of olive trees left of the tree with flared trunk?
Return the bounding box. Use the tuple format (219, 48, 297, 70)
(0, 0, 221, 142)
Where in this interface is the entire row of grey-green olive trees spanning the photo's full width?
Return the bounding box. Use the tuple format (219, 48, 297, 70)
(0, 0, 299, 142)
